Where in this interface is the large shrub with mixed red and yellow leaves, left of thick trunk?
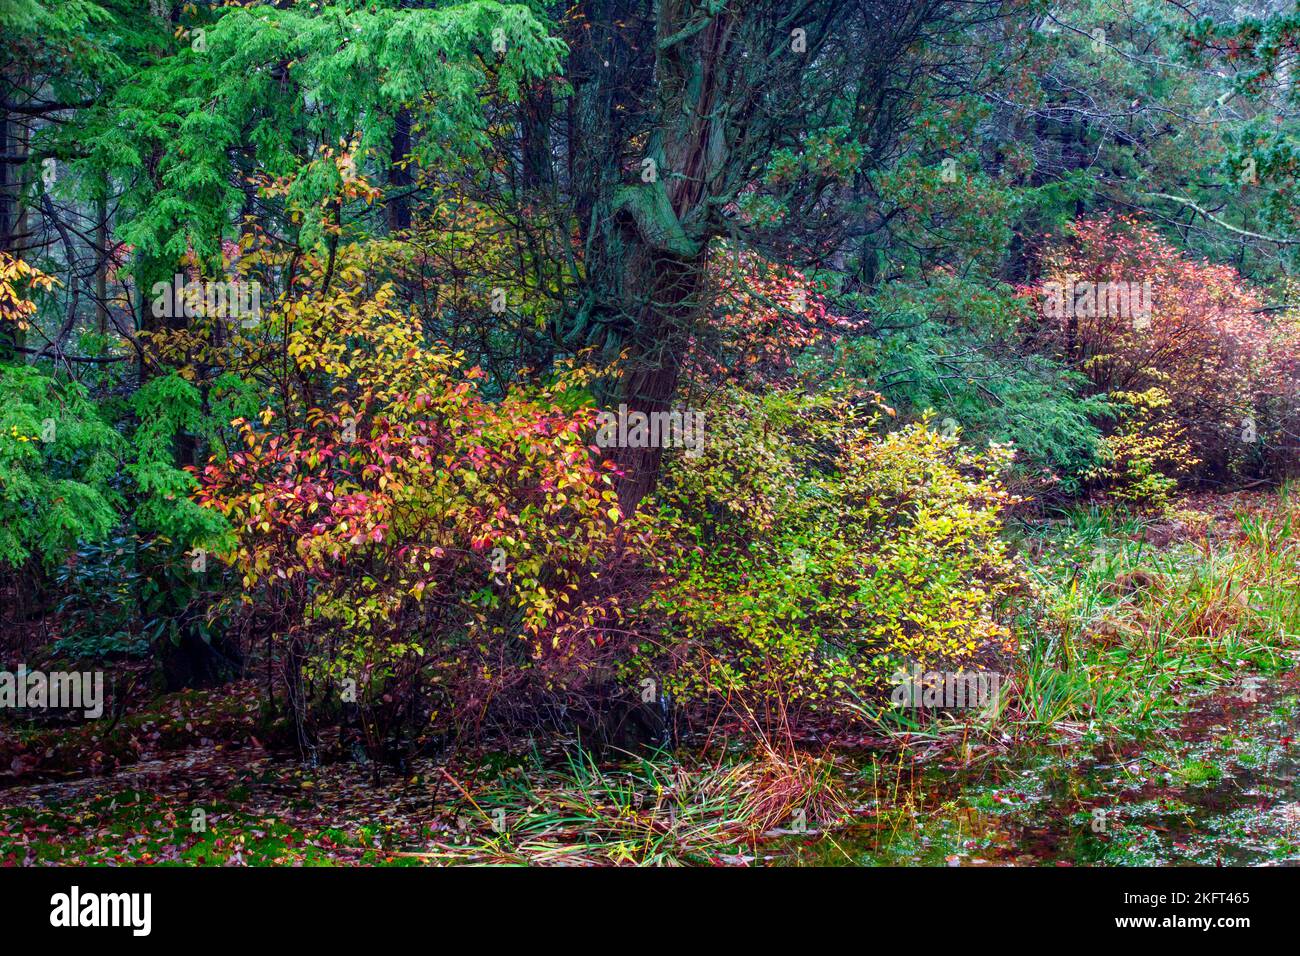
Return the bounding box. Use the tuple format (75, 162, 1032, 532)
(198, 271, 660, 743)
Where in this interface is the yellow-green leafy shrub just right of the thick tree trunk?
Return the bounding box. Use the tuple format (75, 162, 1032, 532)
(636, 390, 1019, 717)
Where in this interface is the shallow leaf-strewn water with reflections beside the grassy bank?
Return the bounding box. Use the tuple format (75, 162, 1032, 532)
(768, 689, 1300, 866)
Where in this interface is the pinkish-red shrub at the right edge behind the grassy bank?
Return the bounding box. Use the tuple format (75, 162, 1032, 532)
(1022, 216, 1300, 486)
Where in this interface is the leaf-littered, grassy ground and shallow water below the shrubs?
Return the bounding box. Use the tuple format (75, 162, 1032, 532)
(0, 494, 1300, 865)
